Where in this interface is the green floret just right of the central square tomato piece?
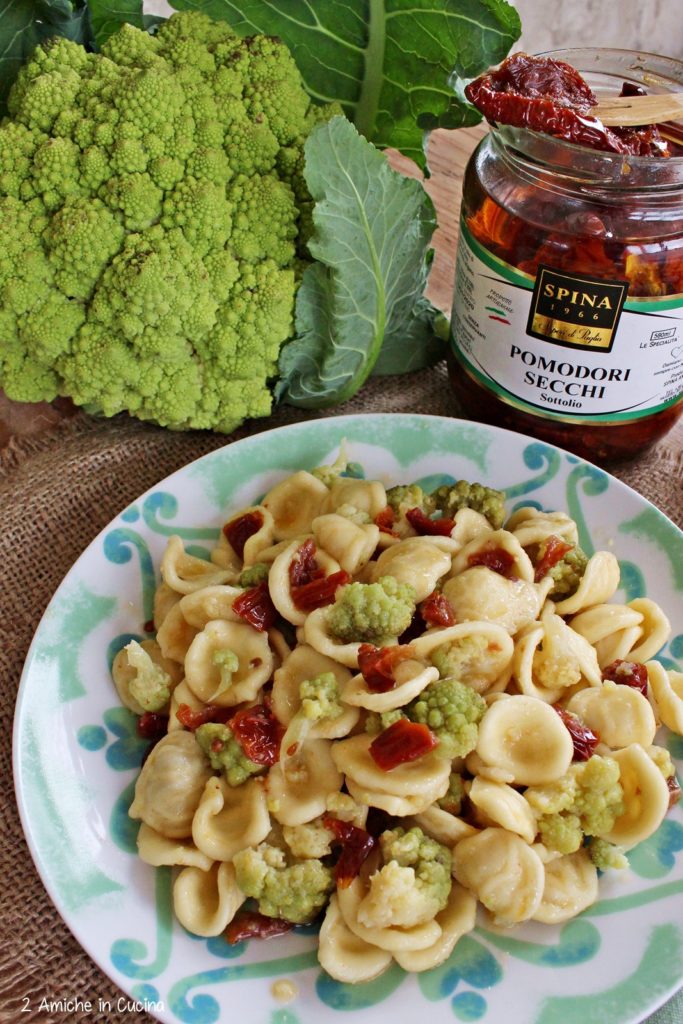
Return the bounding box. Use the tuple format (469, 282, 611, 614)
(403, 679, 486, 759)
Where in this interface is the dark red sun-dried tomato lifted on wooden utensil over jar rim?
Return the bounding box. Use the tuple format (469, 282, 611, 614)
(465, 53, 664, 156)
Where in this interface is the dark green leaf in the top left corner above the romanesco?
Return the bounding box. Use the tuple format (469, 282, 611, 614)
(0, 0, 92, 116)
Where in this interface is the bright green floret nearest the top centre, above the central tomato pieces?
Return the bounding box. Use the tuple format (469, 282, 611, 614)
(328, 577, 415, 647)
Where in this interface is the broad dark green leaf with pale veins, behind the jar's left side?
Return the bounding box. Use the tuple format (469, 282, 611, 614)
(171, 0, 520, 166)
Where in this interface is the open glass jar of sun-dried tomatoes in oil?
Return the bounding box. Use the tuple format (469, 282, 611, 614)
(449, 49, 683, 461)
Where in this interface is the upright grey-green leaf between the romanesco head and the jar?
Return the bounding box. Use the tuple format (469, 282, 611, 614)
(275, 117, 435, 409)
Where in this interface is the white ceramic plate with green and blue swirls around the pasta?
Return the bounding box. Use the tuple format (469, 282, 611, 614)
(14, 415, 683, 1024)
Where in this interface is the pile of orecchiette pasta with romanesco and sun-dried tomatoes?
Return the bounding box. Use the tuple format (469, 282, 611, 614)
(114, 458, 683, 983)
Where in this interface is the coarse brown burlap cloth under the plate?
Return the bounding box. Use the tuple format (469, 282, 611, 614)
(0, 368, 683, 1024)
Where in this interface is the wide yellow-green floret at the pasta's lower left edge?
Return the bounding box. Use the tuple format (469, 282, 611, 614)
(232, 843, 334, 925)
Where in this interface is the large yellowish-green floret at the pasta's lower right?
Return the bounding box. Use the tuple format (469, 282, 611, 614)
(524, 754, 624, 853)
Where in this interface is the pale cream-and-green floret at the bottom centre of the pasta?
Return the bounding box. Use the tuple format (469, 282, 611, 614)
(357, 826, 452, 928)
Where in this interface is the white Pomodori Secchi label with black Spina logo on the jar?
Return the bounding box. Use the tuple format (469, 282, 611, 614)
(451, 223, 683, 423)
